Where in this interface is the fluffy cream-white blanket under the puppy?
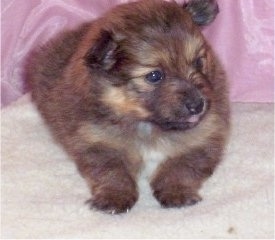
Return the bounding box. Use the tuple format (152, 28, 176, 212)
(1, 95, 274, 239)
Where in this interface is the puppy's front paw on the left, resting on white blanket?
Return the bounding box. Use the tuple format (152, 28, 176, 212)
(88, 188, 138, 214)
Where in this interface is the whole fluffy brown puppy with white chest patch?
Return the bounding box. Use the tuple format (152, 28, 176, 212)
(27, 0, 229, 213)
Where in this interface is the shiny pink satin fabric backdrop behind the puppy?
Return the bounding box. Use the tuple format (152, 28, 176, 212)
(1, 0, 274, 106)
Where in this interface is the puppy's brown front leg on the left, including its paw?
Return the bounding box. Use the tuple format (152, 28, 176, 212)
(77, 144, 138, 213)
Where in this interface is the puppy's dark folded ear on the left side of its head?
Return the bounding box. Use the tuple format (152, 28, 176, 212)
(84, 30, 118, 70)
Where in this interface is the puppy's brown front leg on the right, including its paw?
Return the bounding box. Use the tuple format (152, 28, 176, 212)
(151, 148, 220, 207)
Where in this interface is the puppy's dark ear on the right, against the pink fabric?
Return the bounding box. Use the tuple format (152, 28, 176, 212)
(183, 0, 219, 26)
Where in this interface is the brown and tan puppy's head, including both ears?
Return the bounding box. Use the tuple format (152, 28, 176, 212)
(85, 0, 222, 130)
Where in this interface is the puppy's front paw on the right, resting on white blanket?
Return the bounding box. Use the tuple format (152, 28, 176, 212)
(153, 186, 202, 208)
